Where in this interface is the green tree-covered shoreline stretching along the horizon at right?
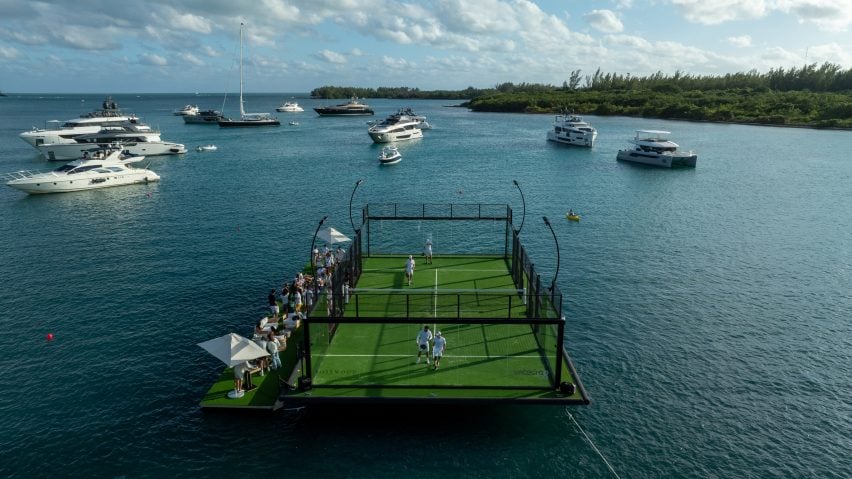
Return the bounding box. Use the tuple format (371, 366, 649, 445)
(311, 63, 852, 129)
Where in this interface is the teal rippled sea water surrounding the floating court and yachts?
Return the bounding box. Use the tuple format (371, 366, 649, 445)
(0, 95, 852, 478)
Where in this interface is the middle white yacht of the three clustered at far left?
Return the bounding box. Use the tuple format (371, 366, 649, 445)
(36, 125, 186, 161)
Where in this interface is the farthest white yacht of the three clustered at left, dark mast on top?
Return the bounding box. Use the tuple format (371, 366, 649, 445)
(20, 97, 144, 147)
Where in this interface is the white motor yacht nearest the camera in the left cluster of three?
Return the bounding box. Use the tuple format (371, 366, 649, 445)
(6, 149, 160, 194)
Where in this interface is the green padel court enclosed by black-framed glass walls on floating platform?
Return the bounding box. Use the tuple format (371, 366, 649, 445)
(301, 203, 572, 394)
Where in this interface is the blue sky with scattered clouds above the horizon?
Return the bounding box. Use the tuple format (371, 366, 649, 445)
(0, 0, 852, 93)
